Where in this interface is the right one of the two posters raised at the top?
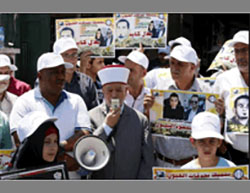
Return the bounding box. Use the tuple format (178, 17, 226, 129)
(115, 13, 168, 49)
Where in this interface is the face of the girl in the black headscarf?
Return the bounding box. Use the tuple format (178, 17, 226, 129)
(43, 133, 58, 162)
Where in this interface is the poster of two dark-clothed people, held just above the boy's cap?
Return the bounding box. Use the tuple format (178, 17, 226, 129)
(150, 89, 219, 137)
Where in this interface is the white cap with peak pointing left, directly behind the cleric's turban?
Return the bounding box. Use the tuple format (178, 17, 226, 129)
(118, 50, 149, 70)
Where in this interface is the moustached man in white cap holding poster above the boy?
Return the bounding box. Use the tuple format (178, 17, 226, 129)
(144, 45, 210, 167)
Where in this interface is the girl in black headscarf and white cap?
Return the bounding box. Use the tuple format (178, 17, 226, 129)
(11, 111, 59, 169)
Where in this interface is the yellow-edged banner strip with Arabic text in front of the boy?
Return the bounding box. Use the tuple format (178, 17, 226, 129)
(153, 165, 249, 180)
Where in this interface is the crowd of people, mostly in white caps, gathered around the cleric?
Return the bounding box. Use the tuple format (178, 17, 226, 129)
(0, 29, 249, 180)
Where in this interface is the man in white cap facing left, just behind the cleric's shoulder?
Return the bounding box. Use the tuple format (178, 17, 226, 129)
(118, 50, 150, 113)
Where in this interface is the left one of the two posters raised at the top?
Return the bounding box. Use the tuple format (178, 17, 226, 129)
(56, 17, 115, 57)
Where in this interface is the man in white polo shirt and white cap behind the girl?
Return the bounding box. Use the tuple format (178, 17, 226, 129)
(10, 52, 90, 178)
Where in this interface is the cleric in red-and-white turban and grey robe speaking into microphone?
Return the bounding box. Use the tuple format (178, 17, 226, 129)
(89, 65, 153, 179)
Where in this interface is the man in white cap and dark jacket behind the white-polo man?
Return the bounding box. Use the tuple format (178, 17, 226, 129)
(53, 37, 98, 110)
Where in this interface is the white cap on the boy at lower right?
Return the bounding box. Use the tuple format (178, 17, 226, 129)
(191, 111, 224, 139)
